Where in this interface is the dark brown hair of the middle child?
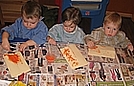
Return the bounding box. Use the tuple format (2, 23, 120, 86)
(62, 7, 82, 25)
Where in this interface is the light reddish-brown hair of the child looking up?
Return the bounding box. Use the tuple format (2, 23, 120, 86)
(104, 12, 122, 28)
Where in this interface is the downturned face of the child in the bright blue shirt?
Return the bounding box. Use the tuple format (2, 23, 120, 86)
(23, 15, 39, 29)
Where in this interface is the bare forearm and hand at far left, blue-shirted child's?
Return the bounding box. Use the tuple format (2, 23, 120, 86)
(2, 31, 10, 51)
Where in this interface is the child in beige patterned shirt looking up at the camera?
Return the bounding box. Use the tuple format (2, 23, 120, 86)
(84, 13, 133, 50)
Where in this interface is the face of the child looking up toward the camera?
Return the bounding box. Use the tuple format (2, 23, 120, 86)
(103, 22, 119, 36)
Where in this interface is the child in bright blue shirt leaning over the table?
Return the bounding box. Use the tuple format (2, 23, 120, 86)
(1, 1, 48, 51)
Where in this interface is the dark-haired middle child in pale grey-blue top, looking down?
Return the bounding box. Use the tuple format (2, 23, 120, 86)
(47, 7, 85, 45)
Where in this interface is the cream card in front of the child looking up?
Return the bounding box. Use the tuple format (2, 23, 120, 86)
(88, 45, 116, 58)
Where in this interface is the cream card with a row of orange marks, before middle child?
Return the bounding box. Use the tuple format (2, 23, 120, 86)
(60, 44, 88, 69)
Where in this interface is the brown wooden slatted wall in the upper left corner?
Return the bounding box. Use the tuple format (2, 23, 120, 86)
(0, 0, 38, 22)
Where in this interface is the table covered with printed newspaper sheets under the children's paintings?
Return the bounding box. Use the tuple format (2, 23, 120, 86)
(0, 42, 134, 86)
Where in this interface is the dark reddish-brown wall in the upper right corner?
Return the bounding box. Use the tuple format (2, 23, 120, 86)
(107, 0, 134, 20)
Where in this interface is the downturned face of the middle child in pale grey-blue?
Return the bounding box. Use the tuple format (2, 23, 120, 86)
(63, 21, 76, 33)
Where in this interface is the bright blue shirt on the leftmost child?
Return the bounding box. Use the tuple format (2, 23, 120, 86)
(0, 18, 48, 44)
